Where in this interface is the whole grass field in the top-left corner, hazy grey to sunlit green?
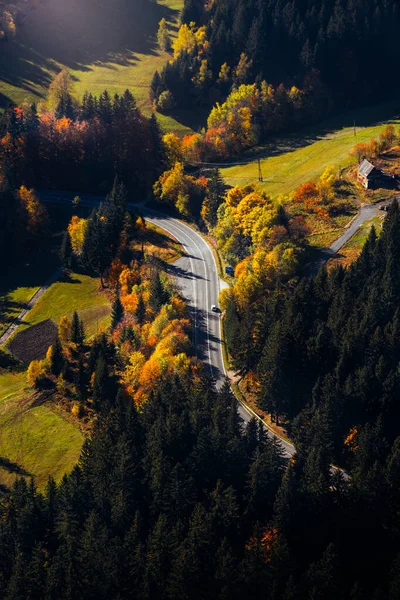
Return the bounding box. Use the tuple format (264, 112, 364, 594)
(0, 0, 190, 132)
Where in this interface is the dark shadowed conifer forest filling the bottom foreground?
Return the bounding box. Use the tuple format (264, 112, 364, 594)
(0, 350, 400, 600)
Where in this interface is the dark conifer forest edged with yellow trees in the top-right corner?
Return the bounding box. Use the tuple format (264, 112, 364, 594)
(150, 0, 400, 159)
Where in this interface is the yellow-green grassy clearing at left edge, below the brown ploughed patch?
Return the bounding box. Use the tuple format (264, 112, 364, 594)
(0, 371, 84, 491)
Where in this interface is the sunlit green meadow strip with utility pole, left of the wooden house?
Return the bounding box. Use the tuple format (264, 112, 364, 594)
(221, 114, 400, 197)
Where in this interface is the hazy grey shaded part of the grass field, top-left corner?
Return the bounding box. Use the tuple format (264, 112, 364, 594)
(0, 0, 178, 100)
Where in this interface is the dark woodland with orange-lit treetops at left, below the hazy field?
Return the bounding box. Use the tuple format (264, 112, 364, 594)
(0, 85, 165, 268)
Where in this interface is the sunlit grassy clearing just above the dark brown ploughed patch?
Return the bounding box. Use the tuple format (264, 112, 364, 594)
(8, 273, 111, 337)
